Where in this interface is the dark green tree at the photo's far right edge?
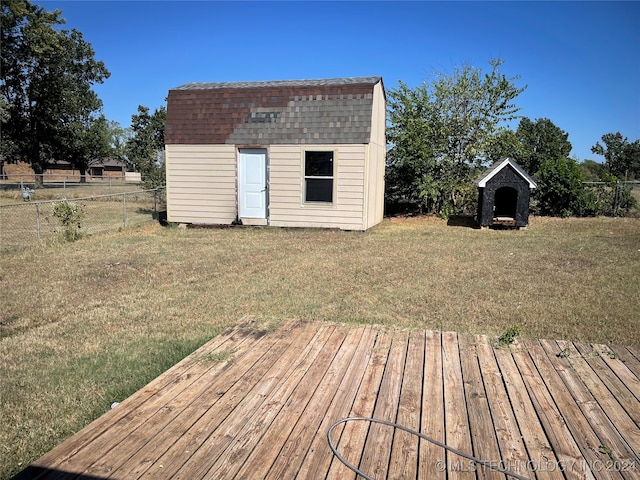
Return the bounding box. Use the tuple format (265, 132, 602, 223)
(591, 132, 640, 180)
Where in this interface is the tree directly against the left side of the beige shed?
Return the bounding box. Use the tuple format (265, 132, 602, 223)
(125, 105, 167, 188)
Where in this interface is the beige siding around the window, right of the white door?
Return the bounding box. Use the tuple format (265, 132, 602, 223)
(269, 145, 367, 230)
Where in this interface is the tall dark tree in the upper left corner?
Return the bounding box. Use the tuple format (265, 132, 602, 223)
(0, 0, 109, 186)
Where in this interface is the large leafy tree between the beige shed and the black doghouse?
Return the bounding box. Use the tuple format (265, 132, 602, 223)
(386, 59, 524, 216)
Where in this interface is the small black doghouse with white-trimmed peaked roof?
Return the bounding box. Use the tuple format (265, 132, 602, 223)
(476, 158, 536, 227)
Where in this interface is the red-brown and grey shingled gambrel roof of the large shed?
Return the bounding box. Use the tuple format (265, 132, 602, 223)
(165, 77, 384, 145)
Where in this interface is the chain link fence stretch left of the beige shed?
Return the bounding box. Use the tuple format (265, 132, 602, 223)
(0, 188, 166, 251)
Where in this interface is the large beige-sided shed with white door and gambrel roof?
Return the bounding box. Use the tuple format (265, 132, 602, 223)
(165, 77, 386, 230)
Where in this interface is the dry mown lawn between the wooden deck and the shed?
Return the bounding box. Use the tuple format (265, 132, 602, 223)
(0, 217, 640, 478)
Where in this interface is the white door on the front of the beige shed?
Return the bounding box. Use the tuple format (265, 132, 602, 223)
(238, 149, 267, 219)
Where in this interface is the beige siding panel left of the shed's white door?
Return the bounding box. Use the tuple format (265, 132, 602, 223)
(166, 145, 237, 224)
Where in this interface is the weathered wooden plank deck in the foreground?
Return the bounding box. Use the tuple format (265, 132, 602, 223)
(17, 322, 640, 480)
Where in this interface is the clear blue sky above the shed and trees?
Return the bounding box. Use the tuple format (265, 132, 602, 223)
(42, 0, 640, 161)
